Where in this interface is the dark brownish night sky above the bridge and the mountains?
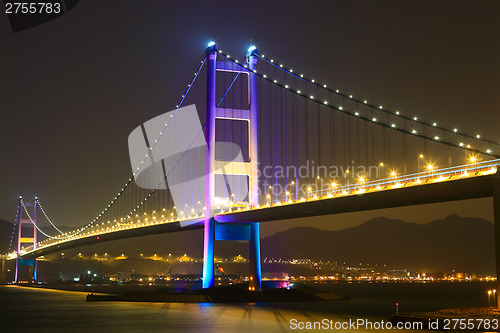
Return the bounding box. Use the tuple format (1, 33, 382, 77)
(0, 0, 500, 235)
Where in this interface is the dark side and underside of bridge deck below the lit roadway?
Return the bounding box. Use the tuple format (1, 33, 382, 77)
(22, 174, 496, 259)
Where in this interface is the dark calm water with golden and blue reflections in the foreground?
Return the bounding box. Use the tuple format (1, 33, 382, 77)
(0, 282, 492, 332)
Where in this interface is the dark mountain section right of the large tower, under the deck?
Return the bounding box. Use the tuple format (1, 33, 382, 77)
(262, 215, 495, 272)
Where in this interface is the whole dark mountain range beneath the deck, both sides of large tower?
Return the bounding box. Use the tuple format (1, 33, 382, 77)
(0, 215, 495, 272)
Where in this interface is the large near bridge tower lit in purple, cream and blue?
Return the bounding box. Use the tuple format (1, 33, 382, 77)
(202, 42, 261, 291)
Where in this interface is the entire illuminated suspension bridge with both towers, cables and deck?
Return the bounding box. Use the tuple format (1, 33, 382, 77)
(4, 42, 500, 296)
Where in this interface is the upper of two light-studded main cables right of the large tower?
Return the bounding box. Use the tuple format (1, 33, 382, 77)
(256, 54, 500, 146)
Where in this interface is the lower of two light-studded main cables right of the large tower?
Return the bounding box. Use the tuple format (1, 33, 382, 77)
(220, 52, 500, 158)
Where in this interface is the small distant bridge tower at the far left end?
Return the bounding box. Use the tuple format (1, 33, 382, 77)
(15, 197, 38, 283)
